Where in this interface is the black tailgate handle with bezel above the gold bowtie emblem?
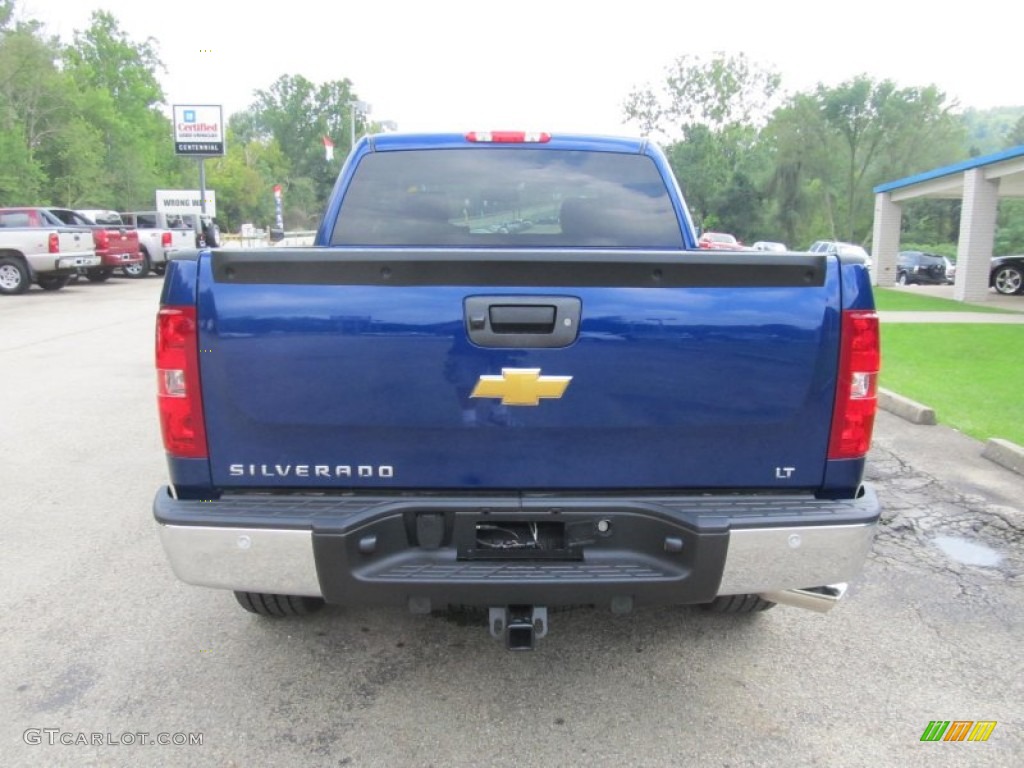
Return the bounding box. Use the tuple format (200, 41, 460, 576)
(465, 296, 581, 348)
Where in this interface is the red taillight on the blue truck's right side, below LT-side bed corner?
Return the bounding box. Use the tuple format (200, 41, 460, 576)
(828, 309, 882, 459)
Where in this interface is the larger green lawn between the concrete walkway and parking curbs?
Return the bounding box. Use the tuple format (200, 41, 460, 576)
(879, 323, 1024, 445)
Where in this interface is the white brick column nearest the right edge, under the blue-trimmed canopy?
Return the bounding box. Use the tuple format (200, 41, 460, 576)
(953, 168, 999, 301)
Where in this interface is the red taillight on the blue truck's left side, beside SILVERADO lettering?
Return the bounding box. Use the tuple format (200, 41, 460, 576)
(157, 306, 207, 459)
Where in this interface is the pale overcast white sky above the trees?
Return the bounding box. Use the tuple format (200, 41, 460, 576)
(15, 0, 1024, 135)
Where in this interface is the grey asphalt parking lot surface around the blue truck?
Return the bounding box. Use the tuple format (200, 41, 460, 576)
(0, 278, 1024, 768)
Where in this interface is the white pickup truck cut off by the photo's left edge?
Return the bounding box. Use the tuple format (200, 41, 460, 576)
(0, 210, 100, 296)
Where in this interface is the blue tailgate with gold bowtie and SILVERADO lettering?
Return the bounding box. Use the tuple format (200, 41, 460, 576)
(199, 249, 841, 492)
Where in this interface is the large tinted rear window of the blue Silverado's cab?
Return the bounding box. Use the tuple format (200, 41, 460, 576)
(331, 147, 683, 249)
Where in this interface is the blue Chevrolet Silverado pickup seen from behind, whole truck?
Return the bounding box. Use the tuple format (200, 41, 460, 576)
(154, 132, 880, 649)
